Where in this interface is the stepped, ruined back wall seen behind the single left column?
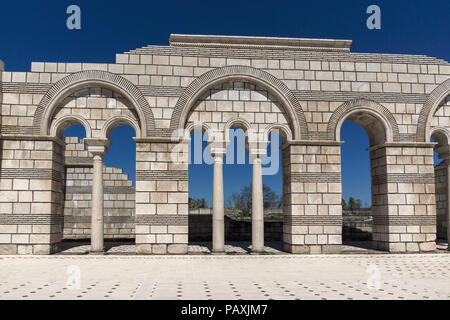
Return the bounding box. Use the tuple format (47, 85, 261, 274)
(64, 138, 135, 240)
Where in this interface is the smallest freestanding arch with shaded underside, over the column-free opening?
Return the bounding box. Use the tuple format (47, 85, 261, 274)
(327, 99, 401, 146)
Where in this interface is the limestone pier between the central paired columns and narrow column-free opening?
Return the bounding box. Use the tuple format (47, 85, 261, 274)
(283, 144, 342, 254)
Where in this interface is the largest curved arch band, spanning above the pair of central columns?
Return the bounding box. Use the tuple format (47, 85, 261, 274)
(170, 66, 308, 140)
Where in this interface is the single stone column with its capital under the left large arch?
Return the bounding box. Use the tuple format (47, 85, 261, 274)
(85, 139, 111, 254)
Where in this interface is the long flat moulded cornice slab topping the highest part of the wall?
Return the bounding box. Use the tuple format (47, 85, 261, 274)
(170, 34, 352, 51)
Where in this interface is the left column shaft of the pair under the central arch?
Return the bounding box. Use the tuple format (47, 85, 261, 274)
(213, 156, 225, 253)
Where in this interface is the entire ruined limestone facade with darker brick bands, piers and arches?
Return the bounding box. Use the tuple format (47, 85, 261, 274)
(0, 35, 450, 254)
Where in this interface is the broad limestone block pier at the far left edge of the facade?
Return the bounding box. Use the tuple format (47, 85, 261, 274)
(0, 138, 64, 254)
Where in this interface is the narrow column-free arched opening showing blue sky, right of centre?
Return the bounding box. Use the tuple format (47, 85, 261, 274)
(336, 110, 389, 252)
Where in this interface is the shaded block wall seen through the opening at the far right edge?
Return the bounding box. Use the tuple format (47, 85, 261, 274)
(434, 162, 448, 239)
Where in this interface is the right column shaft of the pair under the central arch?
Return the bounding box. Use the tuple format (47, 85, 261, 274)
(252, 157, 264, 253)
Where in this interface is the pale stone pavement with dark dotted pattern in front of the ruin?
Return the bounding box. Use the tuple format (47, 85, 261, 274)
(0, 252, 450, 300)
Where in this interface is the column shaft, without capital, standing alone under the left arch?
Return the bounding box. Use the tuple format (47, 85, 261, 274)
(91, 155, 104, 253)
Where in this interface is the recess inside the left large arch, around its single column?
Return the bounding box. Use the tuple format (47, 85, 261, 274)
(49, 87, 142, 254)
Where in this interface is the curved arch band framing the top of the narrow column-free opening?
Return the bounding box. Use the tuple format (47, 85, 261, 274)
(327, 99, 401, 146)
